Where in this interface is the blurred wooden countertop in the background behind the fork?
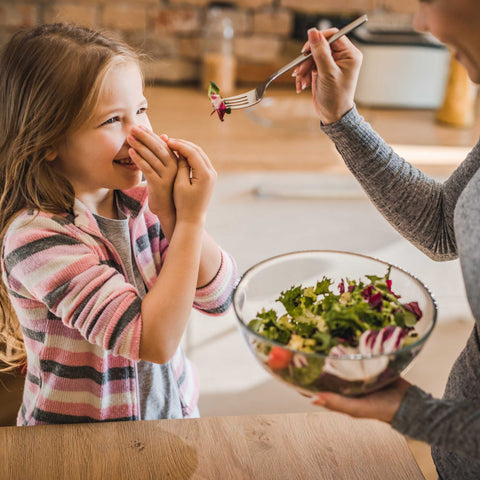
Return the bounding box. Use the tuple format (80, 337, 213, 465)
(146, 87, 480, 174)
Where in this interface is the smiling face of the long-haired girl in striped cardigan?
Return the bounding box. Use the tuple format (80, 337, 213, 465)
(54, 62, 151, 211)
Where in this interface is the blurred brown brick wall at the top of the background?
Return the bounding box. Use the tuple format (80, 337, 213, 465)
(0, 0, 417, 83)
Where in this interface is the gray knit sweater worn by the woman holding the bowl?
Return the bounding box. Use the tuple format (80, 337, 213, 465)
(322, 107, 480, 480)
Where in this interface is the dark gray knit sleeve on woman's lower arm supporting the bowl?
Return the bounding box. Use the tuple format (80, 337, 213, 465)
(392, 386, 480, 461)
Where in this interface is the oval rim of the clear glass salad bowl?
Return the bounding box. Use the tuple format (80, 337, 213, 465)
(232, 249, 438, 360)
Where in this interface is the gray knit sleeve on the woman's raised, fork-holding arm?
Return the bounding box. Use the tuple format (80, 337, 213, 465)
(321, 107, 480, 260)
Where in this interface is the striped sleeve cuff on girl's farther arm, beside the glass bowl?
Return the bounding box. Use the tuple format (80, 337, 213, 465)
(193, 250, 238, 315)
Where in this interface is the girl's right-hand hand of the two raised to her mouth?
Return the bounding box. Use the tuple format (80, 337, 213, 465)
(167, 138, 217, 225)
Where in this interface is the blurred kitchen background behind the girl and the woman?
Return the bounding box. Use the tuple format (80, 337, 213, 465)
(0, 0, 480, 479)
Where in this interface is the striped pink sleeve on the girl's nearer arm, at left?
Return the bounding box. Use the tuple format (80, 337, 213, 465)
(2, 214, 141, 360)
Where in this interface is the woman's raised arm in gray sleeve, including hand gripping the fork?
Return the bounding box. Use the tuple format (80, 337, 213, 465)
(297, 29, 480, 260)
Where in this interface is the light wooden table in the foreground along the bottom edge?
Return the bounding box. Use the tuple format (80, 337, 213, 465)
(0, 412, 424, 480)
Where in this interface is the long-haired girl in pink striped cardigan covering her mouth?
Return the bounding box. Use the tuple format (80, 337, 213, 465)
(0, 24, 236, 425)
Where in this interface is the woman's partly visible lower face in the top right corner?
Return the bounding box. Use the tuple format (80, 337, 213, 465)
(414, 0, 480, 83)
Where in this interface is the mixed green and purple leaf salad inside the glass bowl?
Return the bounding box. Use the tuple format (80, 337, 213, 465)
(248, 267, 422, 389)
